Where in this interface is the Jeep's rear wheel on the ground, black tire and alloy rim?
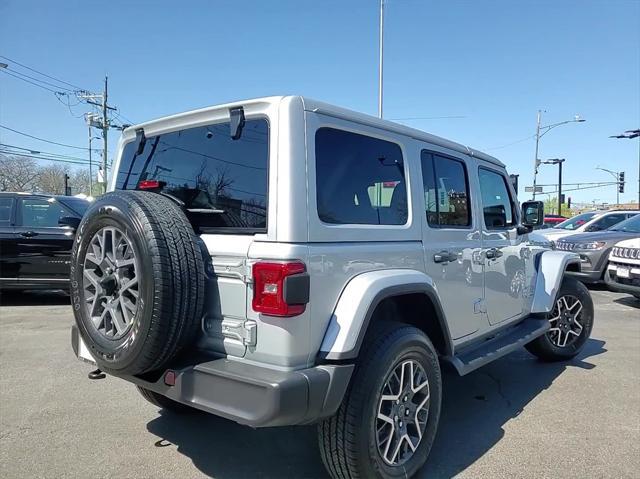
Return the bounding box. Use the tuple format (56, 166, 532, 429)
(318, 323, 442, 479)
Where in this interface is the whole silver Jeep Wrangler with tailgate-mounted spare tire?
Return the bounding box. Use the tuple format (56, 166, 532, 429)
(71, 96, 593, 478)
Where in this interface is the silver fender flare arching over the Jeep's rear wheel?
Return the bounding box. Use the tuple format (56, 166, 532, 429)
(318, 269, 453, 360)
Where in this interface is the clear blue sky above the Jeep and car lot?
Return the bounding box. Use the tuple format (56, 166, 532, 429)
(0, 0, 640, 202)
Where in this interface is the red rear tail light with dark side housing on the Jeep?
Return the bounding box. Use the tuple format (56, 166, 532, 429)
(252, 262, 309, 317)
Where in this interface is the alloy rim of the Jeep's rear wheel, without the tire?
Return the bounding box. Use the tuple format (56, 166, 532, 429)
(376, 359, 430, 466)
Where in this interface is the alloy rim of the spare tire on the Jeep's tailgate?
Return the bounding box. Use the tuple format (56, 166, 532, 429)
(83, 226, 140, 340)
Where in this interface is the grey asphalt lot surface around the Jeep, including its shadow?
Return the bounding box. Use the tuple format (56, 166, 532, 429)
(0, 289, 640, 478)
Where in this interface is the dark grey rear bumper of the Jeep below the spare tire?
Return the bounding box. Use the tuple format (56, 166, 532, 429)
(71, 326, 354, 427)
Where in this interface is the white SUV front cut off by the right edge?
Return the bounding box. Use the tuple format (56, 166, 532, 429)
(605, 237, 640, 299)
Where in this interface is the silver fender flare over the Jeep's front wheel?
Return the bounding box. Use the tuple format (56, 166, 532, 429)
(531, 250, 580, 313)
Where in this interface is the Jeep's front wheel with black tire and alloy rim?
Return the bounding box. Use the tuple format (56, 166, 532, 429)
(526, 277, 593, 361)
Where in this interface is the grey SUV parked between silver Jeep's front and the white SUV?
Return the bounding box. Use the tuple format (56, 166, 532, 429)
(556, 214, 640, 283)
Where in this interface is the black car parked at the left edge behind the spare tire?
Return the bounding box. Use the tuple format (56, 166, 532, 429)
(0, 192, 90, 289)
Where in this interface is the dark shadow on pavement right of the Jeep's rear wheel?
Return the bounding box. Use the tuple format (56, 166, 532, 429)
(416, 339, 607, 479)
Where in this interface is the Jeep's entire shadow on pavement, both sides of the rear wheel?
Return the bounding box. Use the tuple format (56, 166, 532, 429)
(147, 339, 606, 479)
